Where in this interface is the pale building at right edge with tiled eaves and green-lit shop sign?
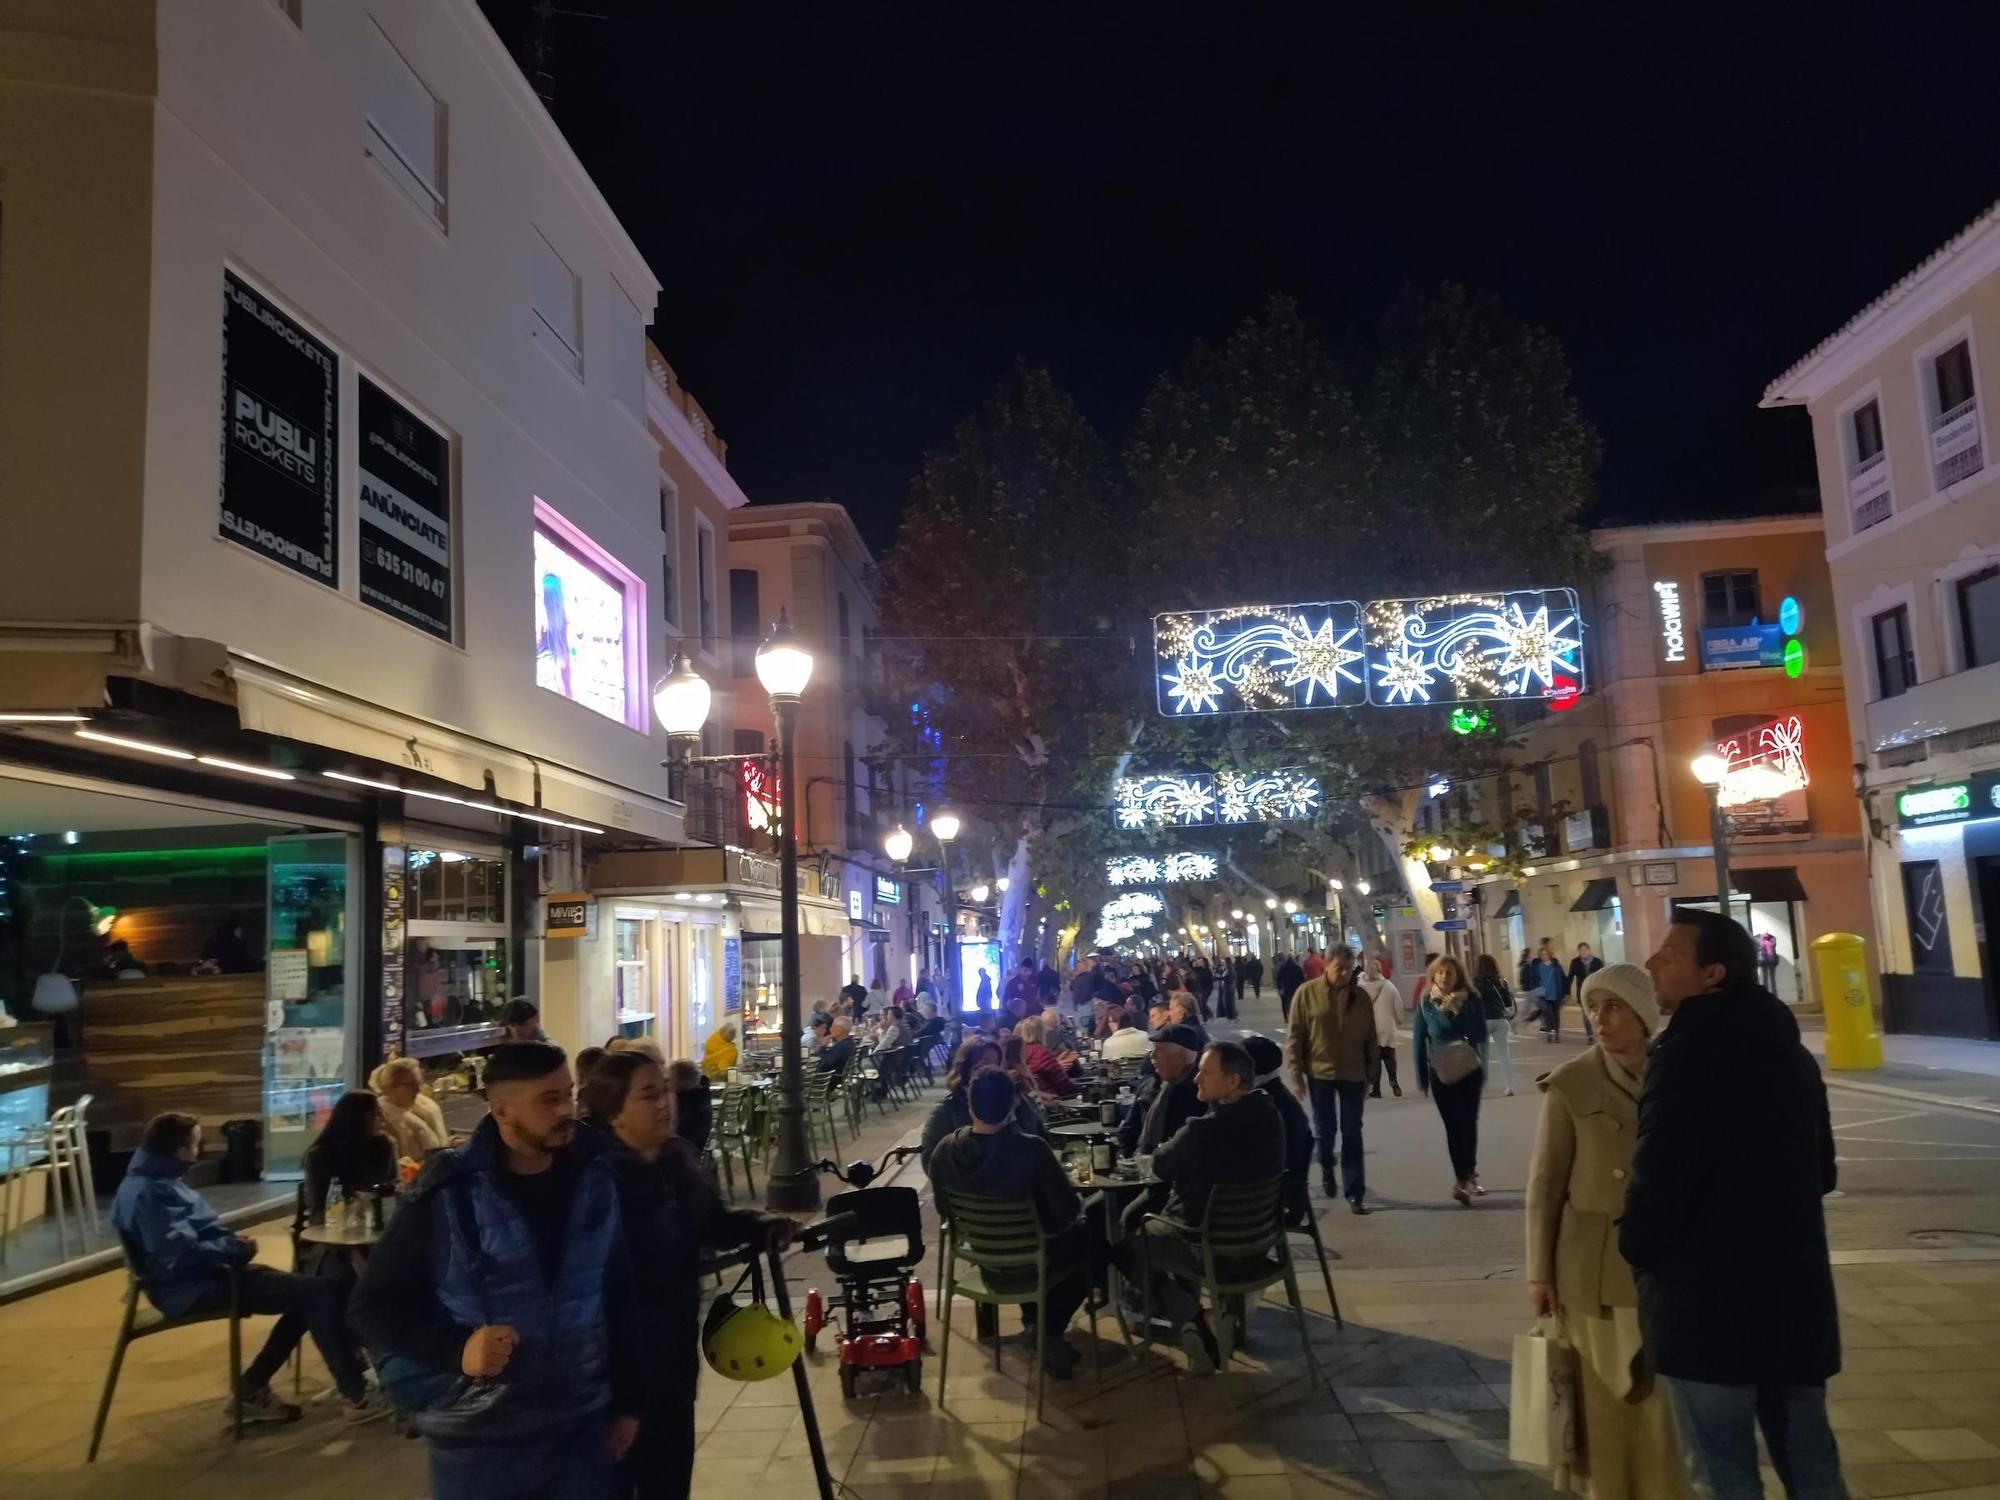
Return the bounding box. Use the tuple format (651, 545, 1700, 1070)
(1764, 208, 2000, 1038)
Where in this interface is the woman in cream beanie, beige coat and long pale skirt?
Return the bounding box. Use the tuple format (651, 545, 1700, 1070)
(1528, 964, 1690, 1500)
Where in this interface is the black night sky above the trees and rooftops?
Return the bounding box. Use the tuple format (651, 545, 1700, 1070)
(482, 0, 2000, 548)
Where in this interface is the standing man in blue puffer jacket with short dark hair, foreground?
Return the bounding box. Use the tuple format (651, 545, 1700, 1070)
(350, 1042, 646, 1500)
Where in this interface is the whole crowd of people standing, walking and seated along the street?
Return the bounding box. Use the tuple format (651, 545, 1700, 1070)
(97, 912, 1846, 1500)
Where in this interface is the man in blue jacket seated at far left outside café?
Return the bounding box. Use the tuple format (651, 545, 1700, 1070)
(112, 1114, 388, 1422)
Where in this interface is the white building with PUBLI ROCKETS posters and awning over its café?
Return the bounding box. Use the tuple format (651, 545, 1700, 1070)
(0, 0, 684, 1176)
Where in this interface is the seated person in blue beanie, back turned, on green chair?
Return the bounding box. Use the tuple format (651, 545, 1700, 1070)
(930, 1068, 1090, 1380)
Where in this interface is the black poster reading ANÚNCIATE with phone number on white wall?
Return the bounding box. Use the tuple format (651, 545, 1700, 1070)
(354, 376, 452, 640)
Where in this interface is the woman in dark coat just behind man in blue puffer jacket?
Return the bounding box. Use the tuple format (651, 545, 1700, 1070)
(582, 1052, 792, 1500)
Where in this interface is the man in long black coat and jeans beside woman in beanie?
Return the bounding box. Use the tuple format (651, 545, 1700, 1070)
(1618, 912, 1848, 1500)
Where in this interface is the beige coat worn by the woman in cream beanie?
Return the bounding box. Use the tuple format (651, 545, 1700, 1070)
(1528, 1048, 1638, 1318)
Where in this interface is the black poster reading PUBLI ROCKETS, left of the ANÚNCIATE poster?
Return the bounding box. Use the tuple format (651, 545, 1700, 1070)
(220, 272, 340, 586)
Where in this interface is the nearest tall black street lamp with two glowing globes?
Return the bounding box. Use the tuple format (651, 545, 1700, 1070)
(652, 610, 820, 1214)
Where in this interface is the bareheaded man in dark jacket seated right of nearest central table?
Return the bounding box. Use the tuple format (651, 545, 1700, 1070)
(1120, 1042, 1284, 1374)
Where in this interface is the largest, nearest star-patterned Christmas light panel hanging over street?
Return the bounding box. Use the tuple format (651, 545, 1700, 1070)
(1152, 588, 1584, 718)
